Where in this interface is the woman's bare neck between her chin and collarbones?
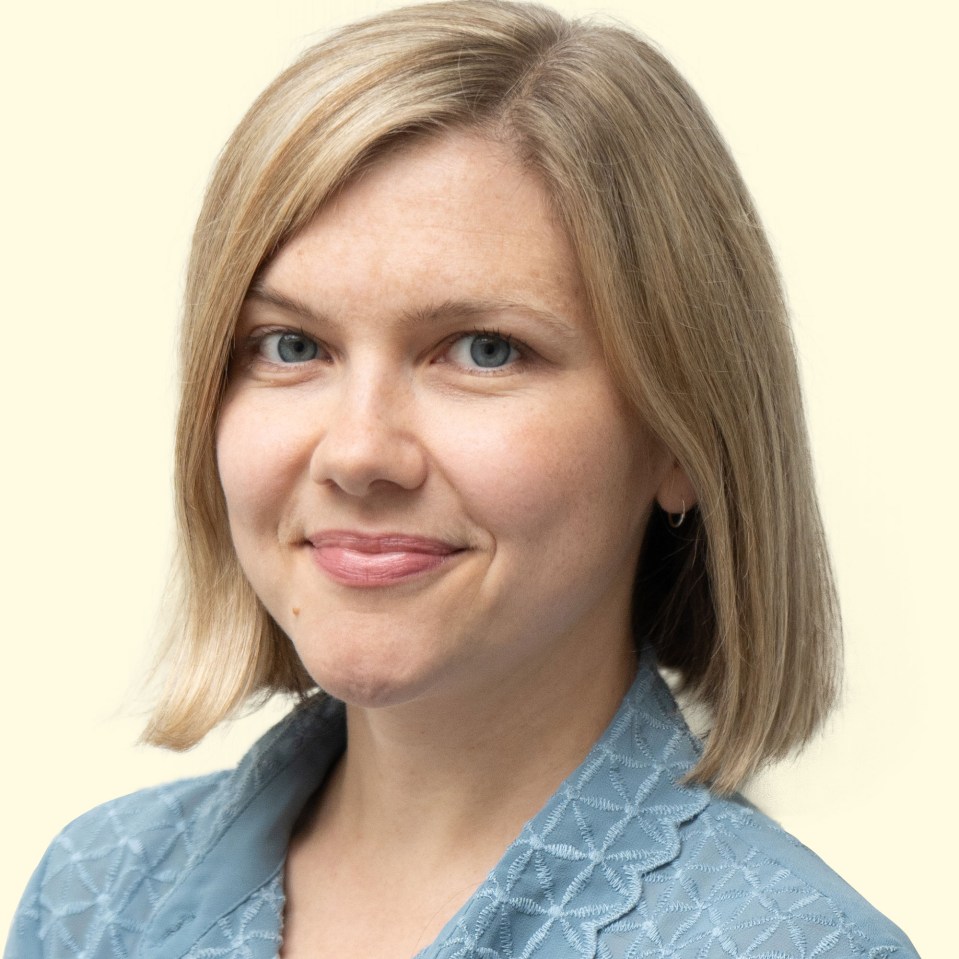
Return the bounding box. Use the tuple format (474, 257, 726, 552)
(311, 632, 635, 868)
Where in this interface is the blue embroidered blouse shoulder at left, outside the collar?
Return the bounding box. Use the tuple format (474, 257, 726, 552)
(5, 773, 228, 959)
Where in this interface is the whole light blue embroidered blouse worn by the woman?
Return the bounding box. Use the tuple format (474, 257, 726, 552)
(5, 662, 916, 959)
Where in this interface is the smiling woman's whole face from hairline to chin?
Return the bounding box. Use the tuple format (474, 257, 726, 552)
(217, 135, 670, 706)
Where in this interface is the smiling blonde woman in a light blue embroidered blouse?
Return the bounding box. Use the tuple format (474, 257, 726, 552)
(10, 0, 915, 957)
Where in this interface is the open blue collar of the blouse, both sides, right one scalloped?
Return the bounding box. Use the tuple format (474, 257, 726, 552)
(141, 655, 709, 959)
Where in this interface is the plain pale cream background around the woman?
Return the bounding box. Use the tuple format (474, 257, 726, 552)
(0, 0, 959, 957)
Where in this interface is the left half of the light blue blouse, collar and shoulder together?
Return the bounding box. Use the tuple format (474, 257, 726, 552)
(4, 697, 345, 959)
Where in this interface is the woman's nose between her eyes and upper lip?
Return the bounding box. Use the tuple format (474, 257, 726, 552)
(310, 371, 427, 496)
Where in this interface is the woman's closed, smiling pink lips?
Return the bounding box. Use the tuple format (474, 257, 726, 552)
(307, 530, 461, 588)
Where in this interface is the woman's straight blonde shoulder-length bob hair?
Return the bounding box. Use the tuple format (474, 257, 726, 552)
(145, 0, 839, 791)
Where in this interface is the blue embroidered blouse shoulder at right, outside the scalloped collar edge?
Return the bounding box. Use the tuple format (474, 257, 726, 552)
(617, 797, 917, 959)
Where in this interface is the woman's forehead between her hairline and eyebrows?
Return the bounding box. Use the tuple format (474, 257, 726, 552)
(258, 134, 582, 326)
